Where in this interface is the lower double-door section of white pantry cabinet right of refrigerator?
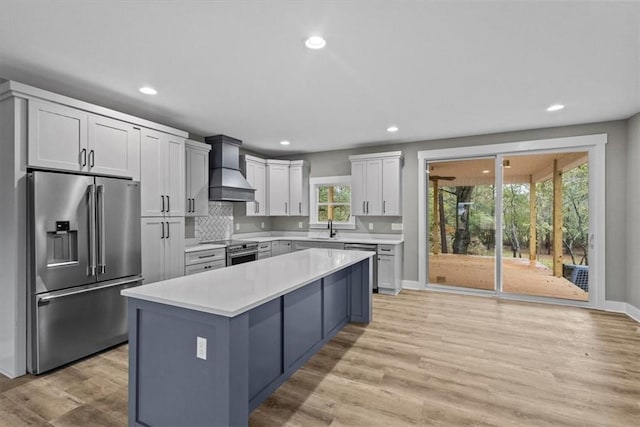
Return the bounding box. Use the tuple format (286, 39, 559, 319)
(141, 217, 184, 284)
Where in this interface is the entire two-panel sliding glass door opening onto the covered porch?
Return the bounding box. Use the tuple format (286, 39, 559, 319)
(425, 150, 590, 302)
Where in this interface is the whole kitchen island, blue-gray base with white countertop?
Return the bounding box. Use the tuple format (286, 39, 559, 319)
(122, 249, 375, 426)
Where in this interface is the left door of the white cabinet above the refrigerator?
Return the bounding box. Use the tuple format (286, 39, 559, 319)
(28, 100, 89, 172)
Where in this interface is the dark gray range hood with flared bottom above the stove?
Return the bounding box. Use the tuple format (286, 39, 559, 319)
(204, 135, 256, 202)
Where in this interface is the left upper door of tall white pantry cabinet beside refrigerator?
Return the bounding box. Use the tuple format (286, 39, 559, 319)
(140, 129, 166, 216)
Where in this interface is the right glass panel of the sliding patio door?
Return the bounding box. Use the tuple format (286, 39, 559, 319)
(501, 151, 589, 301)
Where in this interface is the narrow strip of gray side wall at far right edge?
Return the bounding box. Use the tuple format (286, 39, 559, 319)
(623, 113, 640, 308)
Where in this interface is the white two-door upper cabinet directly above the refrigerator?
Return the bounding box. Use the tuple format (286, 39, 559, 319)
(28, 99, 140, 180)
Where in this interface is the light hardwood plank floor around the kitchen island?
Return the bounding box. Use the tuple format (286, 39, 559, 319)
(0, 290, 640, 427)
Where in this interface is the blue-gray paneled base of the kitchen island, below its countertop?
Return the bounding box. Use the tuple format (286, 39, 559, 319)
(128, 258, 372, 427)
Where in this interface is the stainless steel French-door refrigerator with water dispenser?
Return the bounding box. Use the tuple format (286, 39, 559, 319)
(27, 171, 142, 374)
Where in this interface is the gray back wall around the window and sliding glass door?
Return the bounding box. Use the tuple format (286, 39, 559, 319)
(272, 118, 624, 306)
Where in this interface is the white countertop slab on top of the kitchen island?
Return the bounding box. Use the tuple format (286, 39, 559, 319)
(122, 249, 375, 317)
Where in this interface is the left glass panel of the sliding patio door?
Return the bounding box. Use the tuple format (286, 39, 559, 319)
(428, 158, 496, 290)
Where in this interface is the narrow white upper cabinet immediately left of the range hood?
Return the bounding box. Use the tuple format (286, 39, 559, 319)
(185, 141, 211, 216)
